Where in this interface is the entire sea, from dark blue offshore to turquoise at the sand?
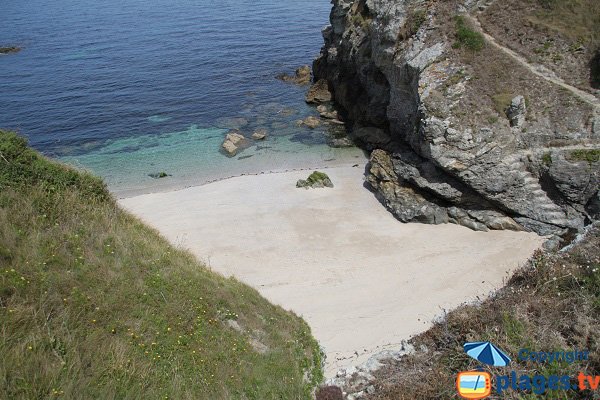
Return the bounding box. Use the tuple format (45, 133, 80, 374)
(0, 0, 364, 195)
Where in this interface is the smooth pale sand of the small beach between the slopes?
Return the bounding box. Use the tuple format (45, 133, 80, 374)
(120, 166, 543, 377)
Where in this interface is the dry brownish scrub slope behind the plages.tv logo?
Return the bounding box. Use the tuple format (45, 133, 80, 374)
(368, 227, 600, 400)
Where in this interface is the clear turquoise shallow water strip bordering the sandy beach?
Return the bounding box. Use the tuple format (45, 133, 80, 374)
(61, 125, 364, 197)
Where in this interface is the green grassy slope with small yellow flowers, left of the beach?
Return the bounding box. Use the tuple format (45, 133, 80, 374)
(0, 131, 322, 400)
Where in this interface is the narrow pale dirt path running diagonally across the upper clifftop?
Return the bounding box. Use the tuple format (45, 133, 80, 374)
(467, 15, 600, 113)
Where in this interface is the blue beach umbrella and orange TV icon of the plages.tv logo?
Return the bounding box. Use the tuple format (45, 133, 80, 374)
(456, 342, 510, 400)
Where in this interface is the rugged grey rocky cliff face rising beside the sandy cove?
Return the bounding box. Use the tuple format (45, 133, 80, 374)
(313, 0, 600, 235)
